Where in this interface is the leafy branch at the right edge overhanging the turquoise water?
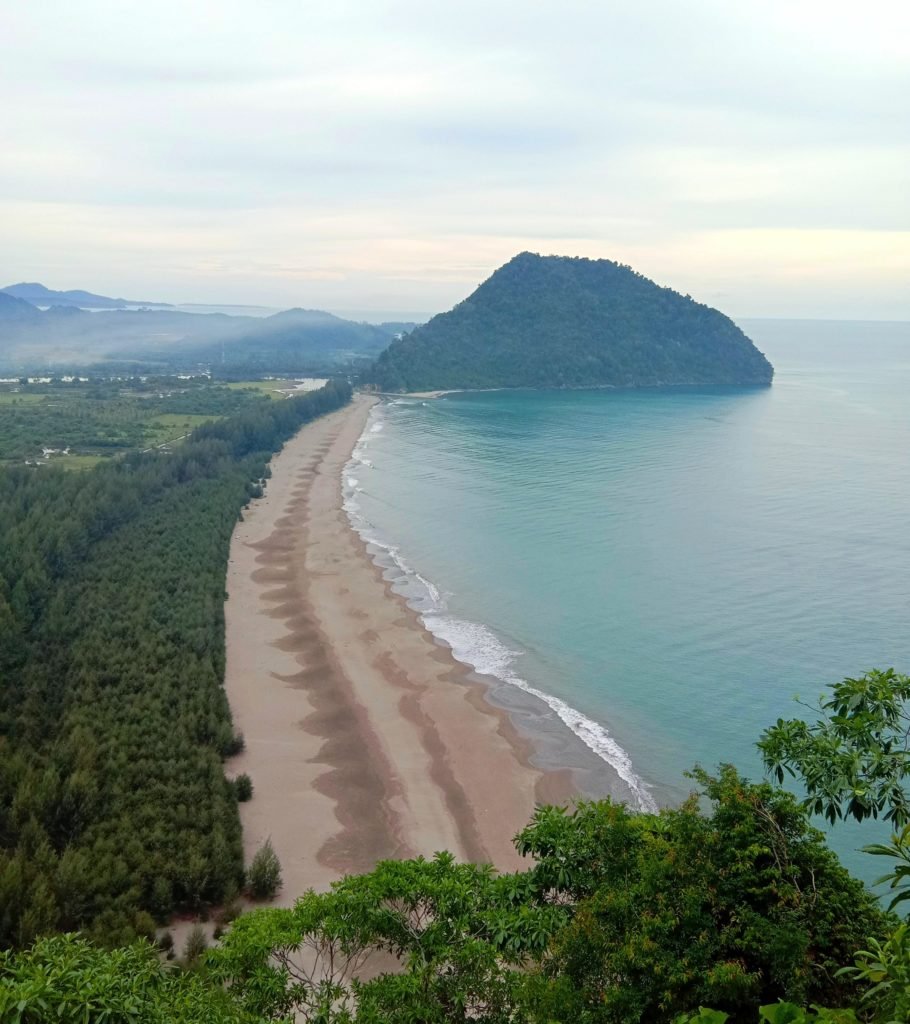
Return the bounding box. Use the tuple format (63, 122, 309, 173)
(759, 669, 910, 826)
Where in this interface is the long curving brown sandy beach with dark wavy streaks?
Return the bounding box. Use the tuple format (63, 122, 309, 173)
(225, 396, 571, 904)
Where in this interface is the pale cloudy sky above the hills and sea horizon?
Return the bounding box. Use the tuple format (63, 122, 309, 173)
(0, 0, 910, 319)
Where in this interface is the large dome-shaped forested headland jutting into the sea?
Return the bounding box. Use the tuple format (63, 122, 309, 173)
(374, 253, 774, 391)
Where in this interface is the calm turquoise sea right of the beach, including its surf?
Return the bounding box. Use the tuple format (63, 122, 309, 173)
(345, 321, 910, 878)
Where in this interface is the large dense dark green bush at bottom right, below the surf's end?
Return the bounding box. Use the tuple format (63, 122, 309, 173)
(518, 767, 886, 1024)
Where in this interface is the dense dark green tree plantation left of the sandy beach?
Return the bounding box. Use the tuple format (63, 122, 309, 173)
(0, 382, 350, 946)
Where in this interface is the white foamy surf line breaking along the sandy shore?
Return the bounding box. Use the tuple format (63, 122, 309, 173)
(342, 402, 657, 813)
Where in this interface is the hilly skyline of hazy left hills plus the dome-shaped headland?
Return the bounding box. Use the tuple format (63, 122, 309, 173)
(0, 264, 774, 391)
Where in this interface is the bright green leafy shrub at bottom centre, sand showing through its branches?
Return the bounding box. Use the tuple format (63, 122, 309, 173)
(209, 854, 566, 1024)
